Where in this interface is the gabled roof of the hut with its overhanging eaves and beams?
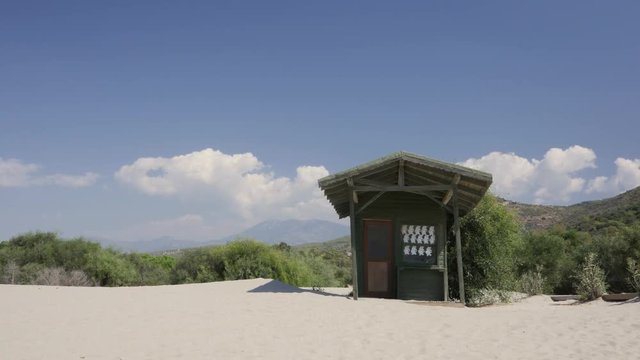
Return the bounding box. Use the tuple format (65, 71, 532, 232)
(318, 151, 492, 218)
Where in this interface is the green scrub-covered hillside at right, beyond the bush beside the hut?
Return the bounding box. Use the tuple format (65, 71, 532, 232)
(499, 187, 640, 293)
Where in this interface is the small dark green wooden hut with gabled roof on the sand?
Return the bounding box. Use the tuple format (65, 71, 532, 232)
(318, 152, 492, 303)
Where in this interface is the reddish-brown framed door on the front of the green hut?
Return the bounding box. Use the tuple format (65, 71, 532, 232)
(363, 220, 395, 298)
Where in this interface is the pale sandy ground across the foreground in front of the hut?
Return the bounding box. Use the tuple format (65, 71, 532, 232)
(0, 279, 640, 360)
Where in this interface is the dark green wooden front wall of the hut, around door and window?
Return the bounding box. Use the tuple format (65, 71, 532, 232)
(355, 192, 447, 300)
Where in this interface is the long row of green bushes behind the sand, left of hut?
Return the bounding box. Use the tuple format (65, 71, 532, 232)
(0, 232, 351, 287)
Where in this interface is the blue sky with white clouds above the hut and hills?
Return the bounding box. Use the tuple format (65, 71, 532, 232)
(0, 1, 640, 240)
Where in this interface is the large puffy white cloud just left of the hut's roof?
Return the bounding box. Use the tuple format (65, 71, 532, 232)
(115, 149, 334, 219)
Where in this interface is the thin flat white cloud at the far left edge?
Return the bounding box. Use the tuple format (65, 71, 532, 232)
(0, 158, 98, 187)
